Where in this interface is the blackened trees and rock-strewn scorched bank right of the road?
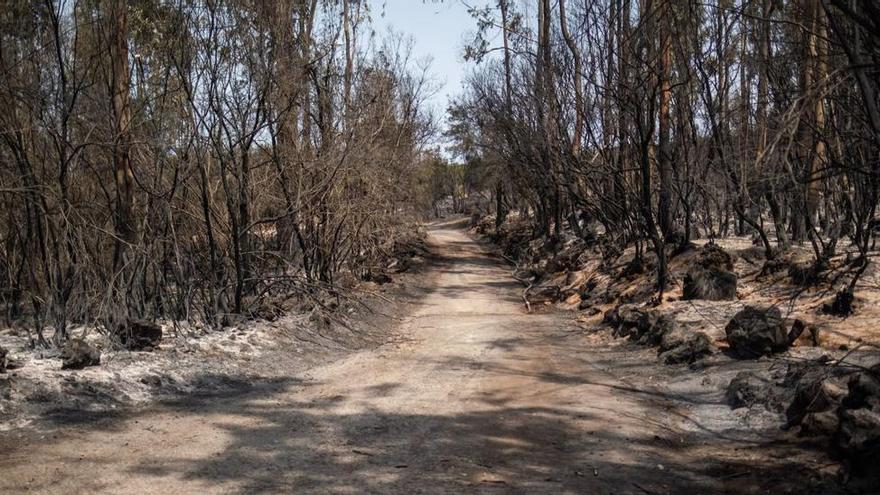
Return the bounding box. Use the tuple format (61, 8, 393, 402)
(449, 0, 880, 480)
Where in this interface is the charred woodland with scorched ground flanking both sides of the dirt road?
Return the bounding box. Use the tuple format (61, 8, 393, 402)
(0, 0, 880, 490)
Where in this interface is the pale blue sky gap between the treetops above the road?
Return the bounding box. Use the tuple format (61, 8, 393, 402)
(370, 0, 486, 119)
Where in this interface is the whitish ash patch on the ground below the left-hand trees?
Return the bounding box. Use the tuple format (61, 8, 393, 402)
(0, 315, 324, 430)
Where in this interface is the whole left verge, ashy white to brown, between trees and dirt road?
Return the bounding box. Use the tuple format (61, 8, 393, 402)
(0, 232, 430, 430)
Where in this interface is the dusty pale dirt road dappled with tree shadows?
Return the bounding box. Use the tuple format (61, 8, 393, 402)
(0, 221, 868, 494)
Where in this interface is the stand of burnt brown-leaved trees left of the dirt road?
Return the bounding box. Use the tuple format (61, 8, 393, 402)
(0, 0, 432, 348)
